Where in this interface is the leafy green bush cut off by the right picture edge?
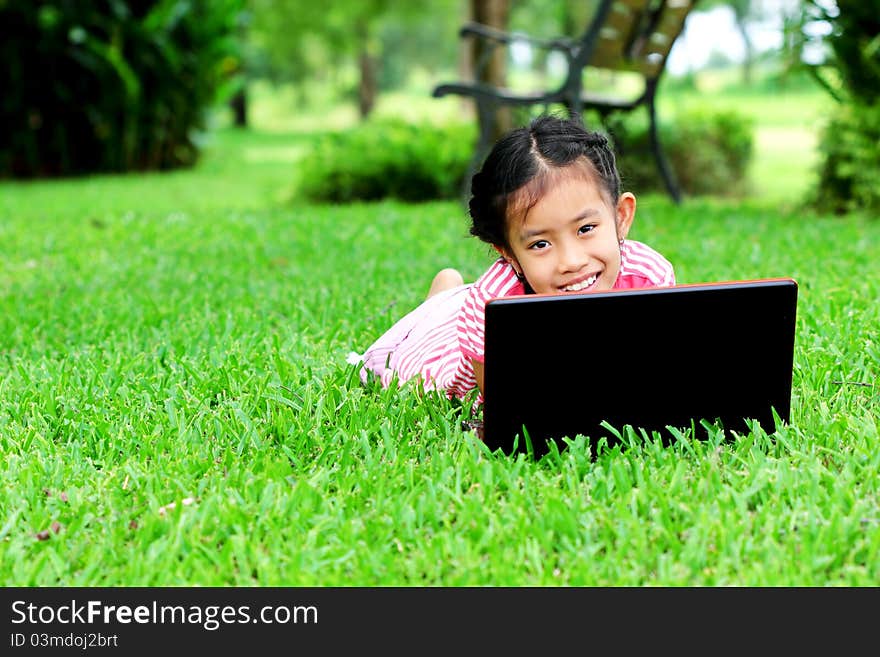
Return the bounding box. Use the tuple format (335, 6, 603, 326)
(810, 103, 880, 214)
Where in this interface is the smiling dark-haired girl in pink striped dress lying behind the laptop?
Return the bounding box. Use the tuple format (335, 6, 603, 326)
(349, 116, 675, 404)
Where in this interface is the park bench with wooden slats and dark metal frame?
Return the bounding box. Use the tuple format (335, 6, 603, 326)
(433, 0, 697, 203)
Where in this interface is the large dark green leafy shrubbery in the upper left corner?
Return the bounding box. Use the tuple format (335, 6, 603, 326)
(0, 0, 240, 177)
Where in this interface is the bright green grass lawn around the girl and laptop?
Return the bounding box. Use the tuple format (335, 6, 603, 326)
(0, 102, 880, 586)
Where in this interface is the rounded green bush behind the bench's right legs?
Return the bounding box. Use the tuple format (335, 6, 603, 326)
(606, 110, 754, 196)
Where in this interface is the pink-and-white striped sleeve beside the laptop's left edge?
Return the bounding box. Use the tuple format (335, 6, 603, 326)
(456, 258, 525, 362)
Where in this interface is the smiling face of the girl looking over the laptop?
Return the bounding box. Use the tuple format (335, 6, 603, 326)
(496, 175, 636, 294)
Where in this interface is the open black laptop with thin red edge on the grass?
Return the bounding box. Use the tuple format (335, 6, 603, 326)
(482, 278, 798, 457)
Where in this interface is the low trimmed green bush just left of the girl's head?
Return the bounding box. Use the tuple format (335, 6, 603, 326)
(298, 119, 476, 203)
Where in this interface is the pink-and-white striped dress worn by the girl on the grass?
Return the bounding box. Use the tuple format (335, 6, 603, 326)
(349, 240, 675, 403)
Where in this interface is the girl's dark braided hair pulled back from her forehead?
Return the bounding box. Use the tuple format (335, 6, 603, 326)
(468, 115, 620, 247)
